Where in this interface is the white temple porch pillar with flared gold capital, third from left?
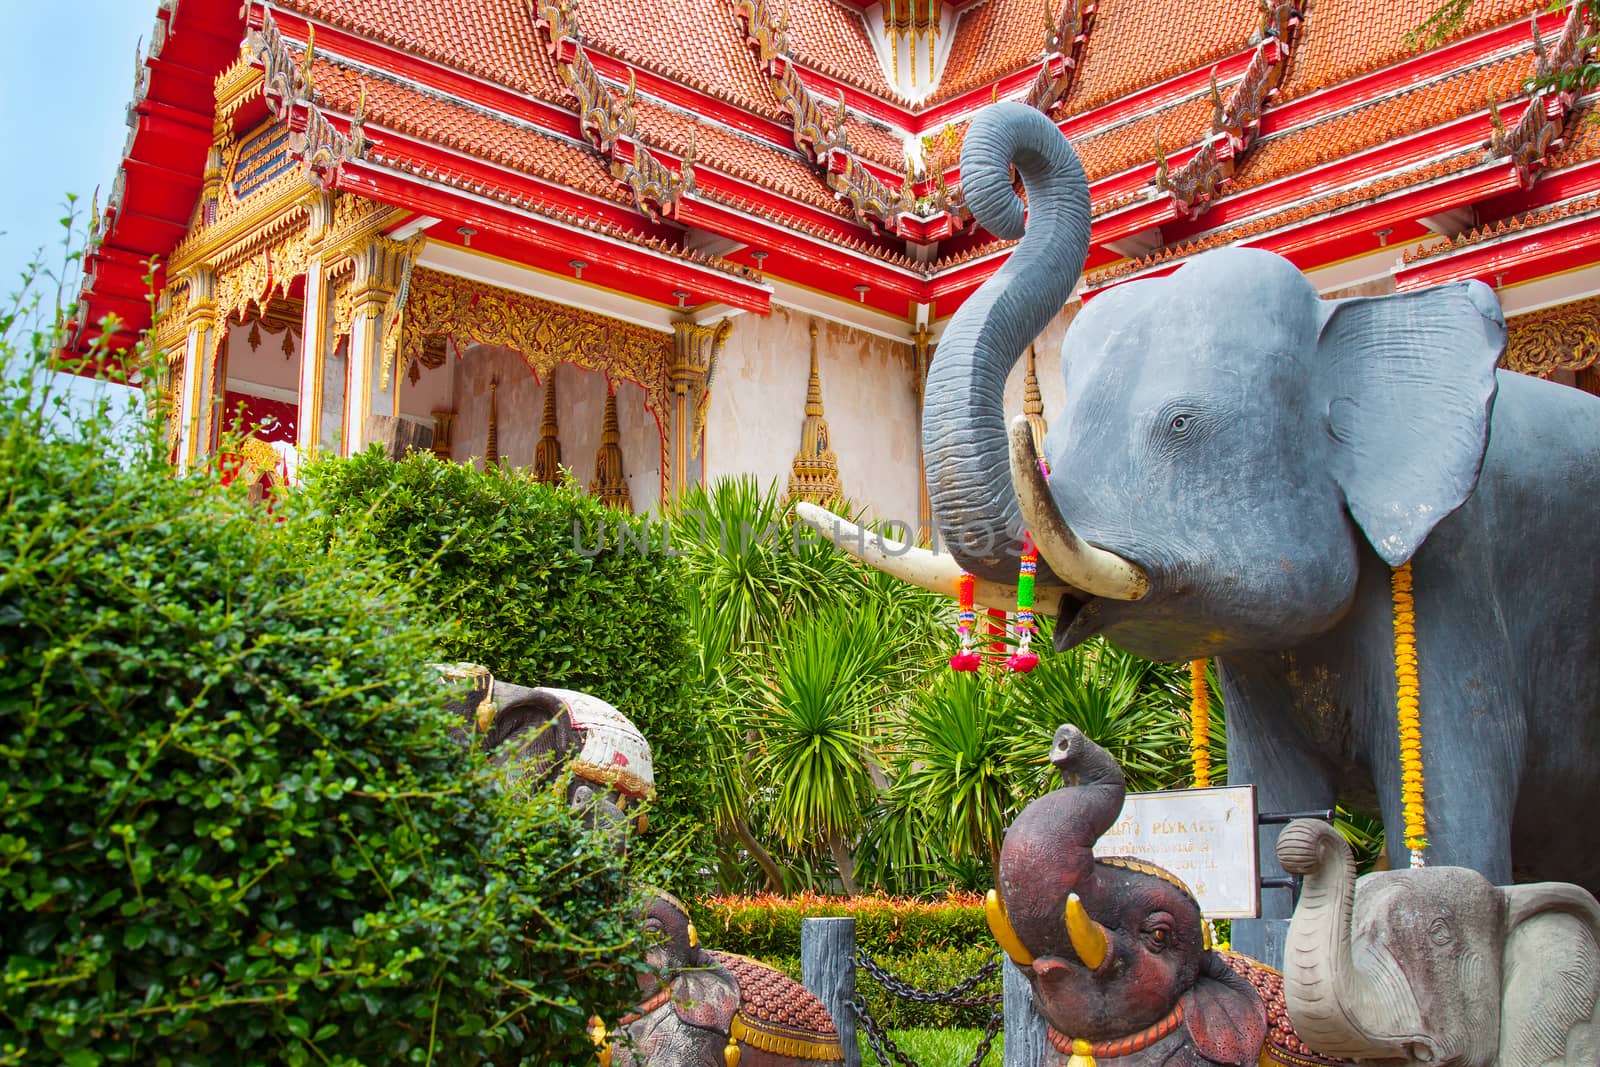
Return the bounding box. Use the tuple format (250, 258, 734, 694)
(342, 237, 414, 456)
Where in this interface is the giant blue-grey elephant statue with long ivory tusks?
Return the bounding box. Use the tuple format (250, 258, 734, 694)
(806, 102, 1600, 918)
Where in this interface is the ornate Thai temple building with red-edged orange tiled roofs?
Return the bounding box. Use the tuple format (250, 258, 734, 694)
(77, 0, 1600, 523)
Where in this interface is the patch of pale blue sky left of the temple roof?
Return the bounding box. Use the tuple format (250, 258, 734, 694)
(0, 0, 157, 294)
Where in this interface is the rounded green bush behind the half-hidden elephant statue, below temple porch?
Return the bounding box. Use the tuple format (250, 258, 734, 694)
(294, 450, 712, 888)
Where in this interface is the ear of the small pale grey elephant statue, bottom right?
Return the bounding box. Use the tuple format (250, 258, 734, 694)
(1498, 881, 1600, 1067)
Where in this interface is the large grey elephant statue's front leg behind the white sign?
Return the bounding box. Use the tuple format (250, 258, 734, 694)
(1218, 656, 1336, 940)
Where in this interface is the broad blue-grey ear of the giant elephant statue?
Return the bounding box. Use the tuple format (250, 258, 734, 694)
(1317, 282, 1506, 566)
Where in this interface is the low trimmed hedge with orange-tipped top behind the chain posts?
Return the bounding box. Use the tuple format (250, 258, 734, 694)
(690, 894, 1000, 1029)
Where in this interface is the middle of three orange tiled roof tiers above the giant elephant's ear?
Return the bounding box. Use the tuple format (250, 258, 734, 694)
(1234, 50, 1533, 190)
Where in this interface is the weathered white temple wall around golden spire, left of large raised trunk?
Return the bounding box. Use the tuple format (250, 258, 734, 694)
(704, 306, 920, 523)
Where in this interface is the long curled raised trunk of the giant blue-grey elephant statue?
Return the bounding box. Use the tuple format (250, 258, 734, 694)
(923, 102, 1090, 582)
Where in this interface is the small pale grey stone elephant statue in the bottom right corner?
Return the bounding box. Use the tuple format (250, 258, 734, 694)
(1278, 821, 1600, 1067)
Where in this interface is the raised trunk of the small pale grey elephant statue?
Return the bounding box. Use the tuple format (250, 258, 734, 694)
(1278, 819, 1405, 1059)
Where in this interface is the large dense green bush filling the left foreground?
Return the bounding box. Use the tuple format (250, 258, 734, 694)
(0, 412, 637, 1067)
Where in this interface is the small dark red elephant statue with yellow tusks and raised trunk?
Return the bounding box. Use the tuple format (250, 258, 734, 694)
(987, 726, 1341, 1067)
